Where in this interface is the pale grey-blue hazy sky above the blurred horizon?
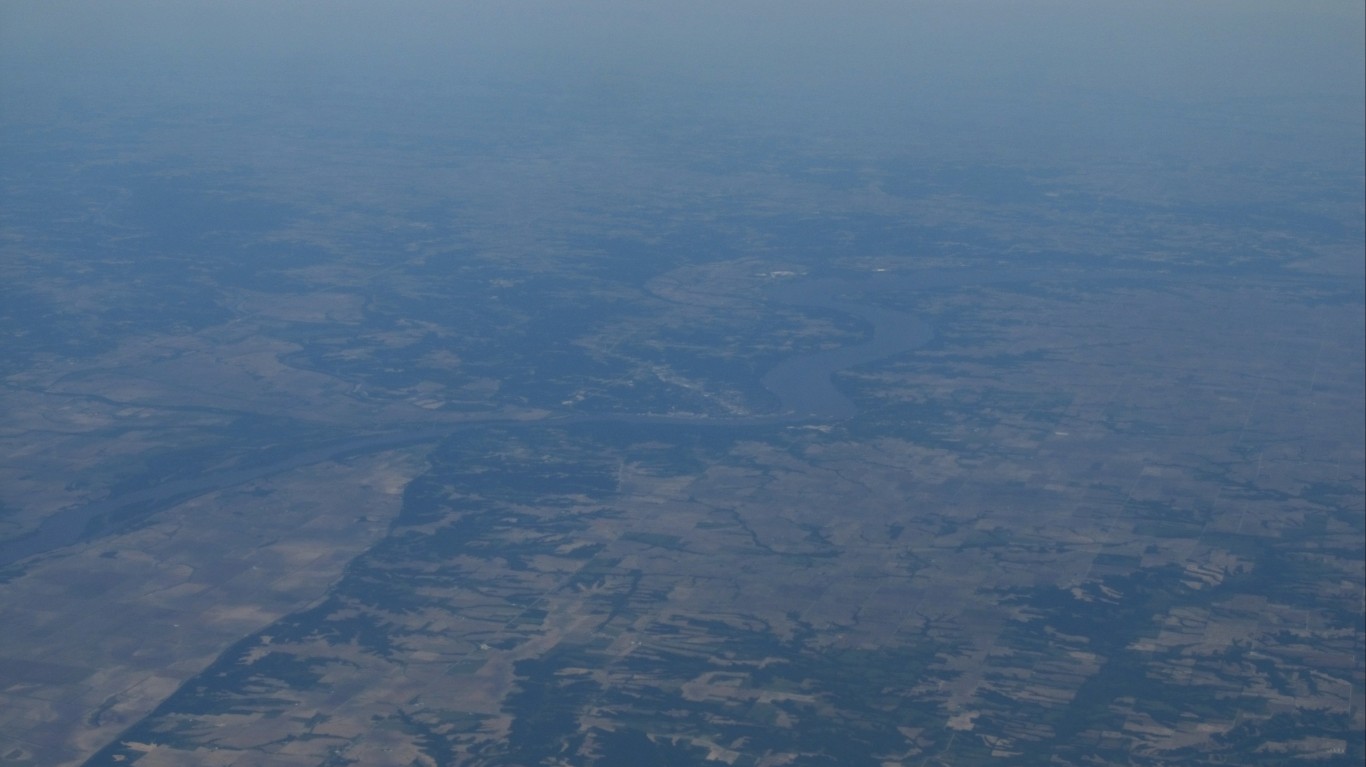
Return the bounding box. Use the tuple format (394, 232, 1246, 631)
(0, 0, 1363, 103)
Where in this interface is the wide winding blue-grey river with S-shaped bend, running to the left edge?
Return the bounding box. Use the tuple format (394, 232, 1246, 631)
(0, 278, 939, 567)
